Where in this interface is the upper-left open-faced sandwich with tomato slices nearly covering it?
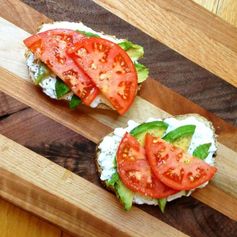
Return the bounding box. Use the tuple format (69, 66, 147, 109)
(24, 22, 148, 115)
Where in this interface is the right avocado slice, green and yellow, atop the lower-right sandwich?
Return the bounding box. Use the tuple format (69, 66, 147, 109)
(162, 125, 196, 151)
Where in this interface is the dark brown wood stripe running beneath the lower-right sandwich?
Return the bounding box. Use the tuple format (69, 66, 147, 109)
(0, 101, 237, 237)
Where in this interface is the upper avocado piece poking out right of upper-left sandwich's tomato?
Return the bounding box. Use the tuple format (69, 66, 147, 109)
(118, 40, 144, 62)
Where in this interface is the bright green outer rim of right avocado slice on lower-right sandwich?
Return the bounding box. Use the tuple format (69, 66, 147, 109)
(163, 125, 196, 143)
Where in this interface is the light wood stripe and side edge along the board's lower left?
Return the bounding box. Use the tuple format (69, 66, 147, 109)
(0, 135, 185, 236)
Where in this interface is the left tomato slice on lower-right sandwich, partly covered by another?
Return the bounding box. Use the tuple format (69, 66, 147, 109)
(117, 133, 177, 198)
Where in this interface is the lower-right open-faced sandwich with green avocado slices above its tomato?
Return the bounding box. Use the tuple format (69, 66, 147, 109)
(96, 114, 217, 211)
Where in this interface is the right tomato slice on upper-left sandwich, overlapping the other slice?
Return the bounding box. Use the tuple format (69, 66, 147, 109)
(68, 38, 138, 114)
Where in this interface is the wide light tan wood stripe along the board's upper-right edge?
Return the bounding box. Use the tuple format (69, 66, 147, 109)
(95, 0, 237, 89)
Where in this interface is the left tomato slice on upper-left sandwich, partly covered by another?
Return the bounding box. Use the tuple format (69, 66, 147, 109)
(24, 29, 99, 105)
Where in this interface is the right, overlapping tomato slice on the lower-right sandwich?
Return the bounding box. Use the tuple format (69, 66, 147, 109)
(145, 134, 217, 190)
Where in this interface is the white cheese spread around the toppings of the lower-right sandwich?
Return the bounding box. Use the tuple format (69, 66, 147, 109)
(98, 115, 217, 205)
